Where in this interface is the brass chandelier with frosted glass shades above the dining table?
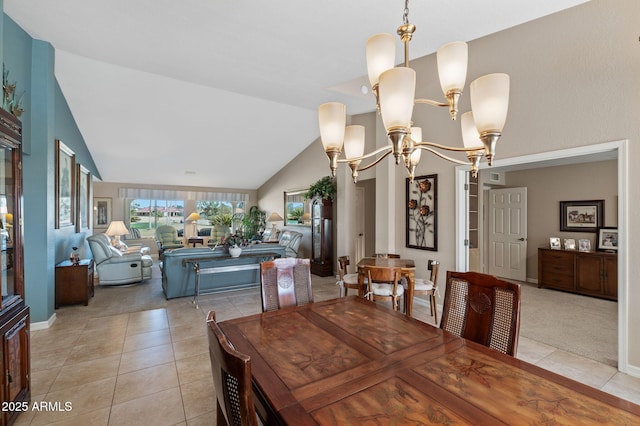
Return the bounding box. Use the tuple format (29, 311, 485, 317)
(318, 0, 509, 182)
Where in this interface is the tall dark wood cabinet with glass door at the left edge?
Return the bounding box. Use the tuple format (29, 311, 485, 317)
(0, 109, 31, 426)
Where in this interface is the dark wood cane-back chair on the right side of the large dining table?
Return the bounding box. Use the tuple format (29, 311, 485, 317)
(440, 271, 520, 356)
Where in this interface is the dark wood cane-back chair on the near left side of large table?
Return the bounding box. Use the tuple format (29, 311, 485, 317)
(207, 311, 258, 426)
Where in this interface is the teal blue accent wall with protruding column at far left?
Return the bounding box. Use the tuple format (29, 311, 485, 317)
(0, 13, 99, 322)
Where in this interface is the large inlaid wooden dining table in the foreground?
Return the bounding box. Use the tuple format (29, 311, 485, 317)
(220, 296, 640, 426)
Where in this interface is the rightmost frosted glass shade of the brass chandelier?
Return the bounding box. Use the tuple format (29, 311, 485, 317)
(471, 73, 509, 134)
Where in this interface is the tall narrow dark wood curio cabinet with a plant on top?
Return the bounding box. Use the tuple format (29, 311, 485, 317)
(311, 198, 333, 277)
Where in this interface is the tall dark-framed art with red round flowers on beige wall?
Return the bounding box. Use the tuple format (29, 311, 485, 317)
(406, 175, 438, 251)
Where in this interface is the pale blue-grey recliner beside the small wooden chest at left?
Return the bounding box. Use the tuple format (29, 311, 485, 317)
(87, 234, 153, 285)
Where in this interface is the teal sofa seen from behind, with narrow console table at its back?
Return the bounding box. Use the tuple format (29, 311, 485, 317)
(160, 244, 285, 299)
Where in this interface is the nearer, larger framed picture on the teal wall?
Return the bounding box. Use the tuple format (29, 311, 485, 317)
(56, 139, 76, 228)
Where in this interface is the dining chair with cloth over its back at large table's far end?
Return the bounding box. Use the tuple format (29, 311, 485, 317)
(260, 257, 313, 312)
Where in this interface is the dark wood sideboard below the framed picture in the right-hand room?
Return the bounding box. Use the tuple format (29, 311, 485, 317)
(538, 248, 618, 300)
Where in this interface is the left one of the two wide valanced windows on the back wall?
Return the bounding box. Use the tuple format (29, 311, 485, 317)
(129, 199, 184, 238)
